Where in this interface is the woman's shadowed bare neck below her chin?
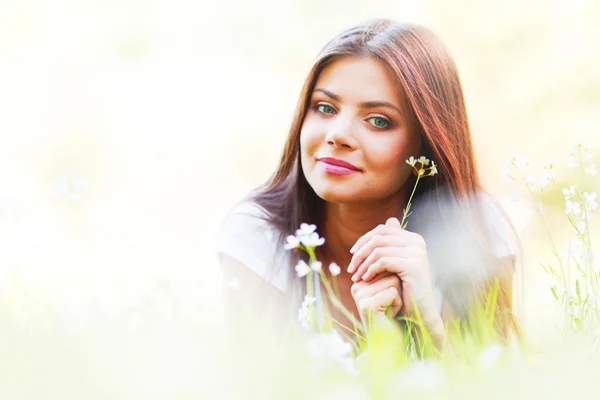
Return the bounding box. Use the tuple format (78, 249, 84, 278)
(321, 190, 410, 270)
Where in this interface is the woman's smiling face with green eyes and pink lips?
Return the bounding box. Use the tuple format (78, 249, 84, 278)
(300, 57, 421, 203)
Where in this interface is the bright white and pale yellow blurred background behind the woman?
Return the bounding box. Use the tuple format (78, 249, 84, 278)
(0, 0, 600, 396)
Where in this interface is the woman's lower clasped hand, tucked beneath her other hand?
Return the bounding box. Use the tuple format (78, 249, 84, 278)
(350, 272, 402, 327)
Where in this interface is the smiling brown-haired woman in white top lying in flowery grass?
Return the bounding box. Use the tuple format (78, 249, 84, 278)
(219, 20, 516, 350)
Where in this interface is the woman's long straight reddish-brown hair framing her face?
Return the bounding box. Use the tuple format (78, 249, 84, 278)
(251, 19, 511, 340)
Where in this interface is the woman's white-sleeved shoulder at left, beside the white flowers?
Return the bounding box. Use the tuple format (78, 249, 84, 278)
(217, 201, 287, 291)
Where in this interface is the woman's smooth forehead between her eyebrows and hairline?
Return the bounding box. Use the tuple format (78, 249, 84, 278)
(315, 57, 403, 108)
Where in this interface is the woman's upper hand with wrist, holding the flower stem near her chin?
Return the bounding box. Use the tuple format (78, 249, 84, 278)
(348, 218, 441, 323)
